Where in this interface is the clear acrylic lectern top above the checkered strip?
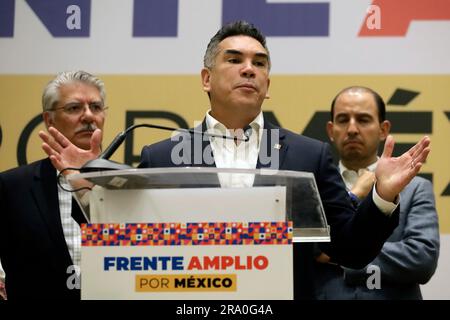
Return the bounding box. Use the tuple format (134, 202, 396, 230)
(67, 167, 330, 242)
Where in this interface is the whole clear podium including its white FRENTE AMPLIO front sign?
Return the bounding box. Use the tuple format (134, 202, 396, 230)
(67, 167, 330, 300)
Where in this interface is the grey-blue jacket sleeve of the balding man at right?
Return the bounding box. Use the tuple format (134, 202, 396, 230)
(345, 179, 439, 284)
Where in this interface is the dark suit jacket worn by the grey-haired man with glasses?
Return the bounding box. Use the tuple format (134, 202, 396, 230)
(0, 159, 80, 299)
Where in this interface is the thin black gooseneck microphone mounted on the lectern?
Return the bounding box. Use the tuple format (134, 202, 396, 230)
(80, 123, 252, 173)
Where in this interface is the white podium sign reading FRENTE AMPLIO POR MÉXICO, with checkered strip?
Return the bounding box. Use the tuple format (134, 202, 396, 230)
(81, 222, 293, 300)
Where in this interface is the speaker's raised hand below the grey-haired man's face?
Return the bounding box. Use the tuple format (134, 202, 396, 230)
(39, 127, 102, 174)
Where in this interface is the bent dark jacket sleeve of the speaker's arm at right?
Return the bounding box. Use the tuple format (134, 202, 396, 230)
(315, 144, 400, 268)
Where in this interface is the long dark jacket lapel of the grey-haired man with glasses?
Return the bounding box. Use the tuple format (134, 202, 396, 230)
(31, 158, 70, 258)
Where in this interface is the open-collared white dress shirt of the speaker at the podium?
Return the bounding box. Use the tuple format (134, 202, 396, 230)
(206, 110, 264, 188)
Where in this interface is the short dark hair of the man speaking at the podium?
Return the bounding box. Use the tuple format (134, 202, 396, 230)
(203, 20, 270, 69)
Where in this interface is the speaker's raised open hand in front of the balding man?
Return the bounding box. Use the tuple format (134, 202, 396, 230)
(375, 135, 430, 202)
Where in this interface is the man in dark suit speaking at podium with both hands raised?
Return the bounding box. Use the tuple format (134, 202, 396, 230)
(40, 21, 430, 298)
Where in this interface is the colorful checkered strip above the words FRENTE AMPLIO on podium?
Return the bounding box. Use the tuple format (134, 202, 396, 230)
(81, 222, 293, 246)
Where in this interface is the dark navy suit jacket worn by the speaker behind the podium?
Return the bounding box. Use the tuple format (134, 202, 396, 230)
(139, 121, 398, 299)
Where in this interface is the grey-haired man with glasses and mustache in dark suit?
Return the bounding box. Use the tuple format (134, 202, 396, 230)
(0, 71, 106, 299)
